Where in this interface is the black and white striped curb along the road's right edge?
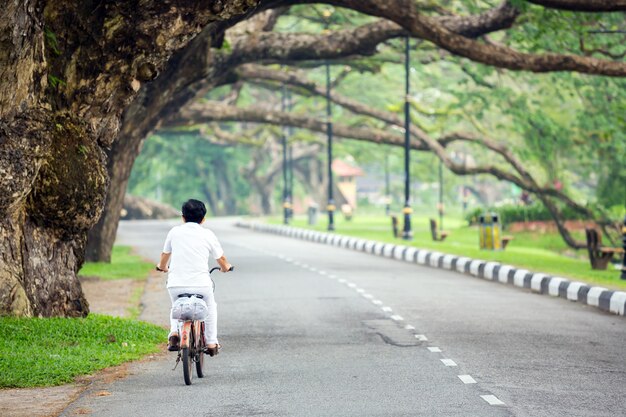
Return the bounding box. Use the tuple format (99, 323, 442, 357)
(237, 221, 626, 316)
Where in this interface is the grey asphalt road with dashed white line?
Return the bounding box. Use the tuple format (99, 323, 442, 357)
(63, 220, 626, 417)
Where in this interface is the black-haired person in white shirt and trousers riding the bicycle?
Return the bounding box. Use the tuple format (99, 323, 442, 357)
(157, 199, 231, 356)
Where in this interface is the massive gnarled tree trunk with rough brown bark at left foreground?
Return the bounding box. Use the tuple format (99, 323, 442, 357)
(0, 0, 256, 316)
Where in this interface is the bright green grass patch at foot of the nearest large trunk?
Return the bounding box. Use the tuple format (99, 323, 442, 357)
(0, 314, 167, 388)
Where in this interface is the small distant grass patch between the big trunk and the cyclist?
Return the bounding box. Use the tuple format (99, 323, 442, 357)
(78, 246, 154, 280)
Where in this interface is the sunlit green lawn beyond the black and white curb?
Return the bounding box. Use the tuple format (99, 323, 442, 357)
(268, 216, 626, 290)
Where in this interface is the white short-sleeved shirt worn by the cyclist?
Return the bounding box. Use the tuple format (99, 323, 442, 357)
(163, 222, 224, 288)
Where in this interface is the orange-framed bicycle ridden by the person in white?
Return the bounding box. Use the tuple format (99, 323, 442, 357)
(168, 266, 234, 385)
